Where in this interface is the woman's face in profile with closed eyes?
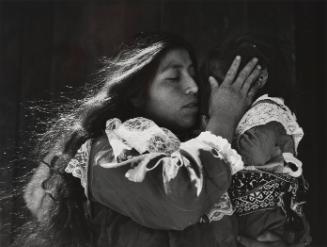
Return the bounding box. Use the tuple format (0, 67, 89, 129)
(144, 49, 199, 131)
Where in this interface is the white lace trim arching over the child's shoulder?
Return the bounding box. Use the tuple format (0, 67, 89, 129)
(236, 94, 304, 153)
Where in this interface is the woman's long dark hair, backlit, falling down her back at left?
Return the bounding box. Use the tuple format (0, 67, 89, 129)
(13, 34, 199, 247)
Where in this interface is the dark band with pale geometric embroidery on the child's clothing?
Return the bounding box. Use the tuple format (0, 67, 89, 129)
(229, 170, 303, 216)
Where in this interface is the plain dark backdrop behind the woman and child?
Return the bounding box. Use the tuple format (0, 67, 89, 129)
(0, 0, 327, 246)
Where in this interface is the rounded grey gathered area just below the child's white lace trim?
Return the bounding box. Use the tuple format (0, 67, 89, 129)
(239, 128, 280, 166)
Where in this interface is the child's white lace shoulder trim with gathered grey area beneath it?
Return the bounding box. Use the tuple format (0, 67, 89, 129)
(234, 95, 303, 176)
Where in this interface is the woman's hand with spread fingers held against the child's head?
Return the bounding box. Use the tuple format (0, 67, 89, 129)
(207, 56, 263, 140)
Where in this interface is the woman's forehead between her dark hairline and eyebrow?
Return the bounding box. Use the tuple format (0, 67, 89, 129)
(159, 49, 193, 72)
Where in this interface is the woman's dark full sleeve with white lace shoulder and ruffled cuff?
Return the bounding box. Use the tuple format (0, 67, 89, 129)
(88, 118, 243, 230)
